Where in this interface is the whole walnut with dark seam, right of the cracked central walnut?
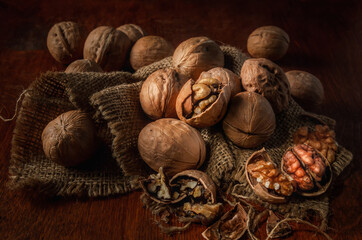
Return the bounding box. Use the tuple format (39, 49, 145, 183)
(223, 92, 276, 148)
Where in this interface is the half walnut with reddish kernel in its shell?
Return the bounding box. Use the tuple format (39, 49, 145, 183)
(281, 144, 332, 196)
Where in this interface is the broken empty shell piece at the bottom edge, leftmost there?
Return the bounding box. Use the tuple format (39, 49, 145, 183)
(202, 203, 247, 240)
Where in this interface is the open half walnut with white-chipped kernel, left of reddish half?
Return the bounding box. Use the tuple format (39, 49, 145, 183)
(245, 148, 294, 203)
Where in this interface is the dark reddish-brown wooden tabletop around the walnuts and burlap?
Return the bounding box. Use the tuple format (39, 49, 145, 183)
(0, 0, 362, 239)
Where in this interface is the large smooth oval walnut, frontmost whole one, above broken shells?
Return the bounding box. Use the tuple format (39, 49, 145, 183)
(138, 118, 206, 176)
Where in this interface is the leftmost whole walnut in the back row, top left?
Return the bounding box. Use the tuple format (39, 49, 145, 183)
(47, 22, 87, 64)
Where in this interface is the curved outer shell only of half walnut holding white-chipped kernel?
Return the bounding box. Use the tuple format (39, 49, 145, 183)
(245, 148, 288, 203)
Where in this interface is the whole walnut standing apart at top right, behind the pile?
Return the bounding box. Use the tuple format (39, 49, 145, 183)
(247, 26, 290, 60)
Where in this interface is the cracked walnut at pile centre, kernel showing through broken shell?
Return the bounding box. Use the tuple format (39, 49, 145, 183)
(176, 71, 231, 128)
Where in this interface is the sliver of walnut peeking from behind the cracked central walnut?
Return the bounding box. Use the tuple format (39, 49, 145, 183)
(200, 67, 241, 97)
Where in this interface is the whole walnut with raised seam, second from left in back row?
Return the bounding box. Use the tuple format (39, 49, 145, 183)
(83, 26, 131, 72)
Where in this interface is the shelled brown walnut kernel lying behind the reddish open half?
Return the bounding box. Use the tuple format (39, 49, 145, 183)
(293, 125, 338, 163)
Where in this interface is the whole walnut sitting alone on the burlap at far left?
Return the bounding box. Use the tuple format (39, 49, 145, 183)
(41, 110, 98, 167)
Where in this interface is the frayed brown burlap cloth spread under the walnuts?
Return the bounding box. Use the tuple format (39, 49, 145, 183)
(10, 46, 352, 231)
